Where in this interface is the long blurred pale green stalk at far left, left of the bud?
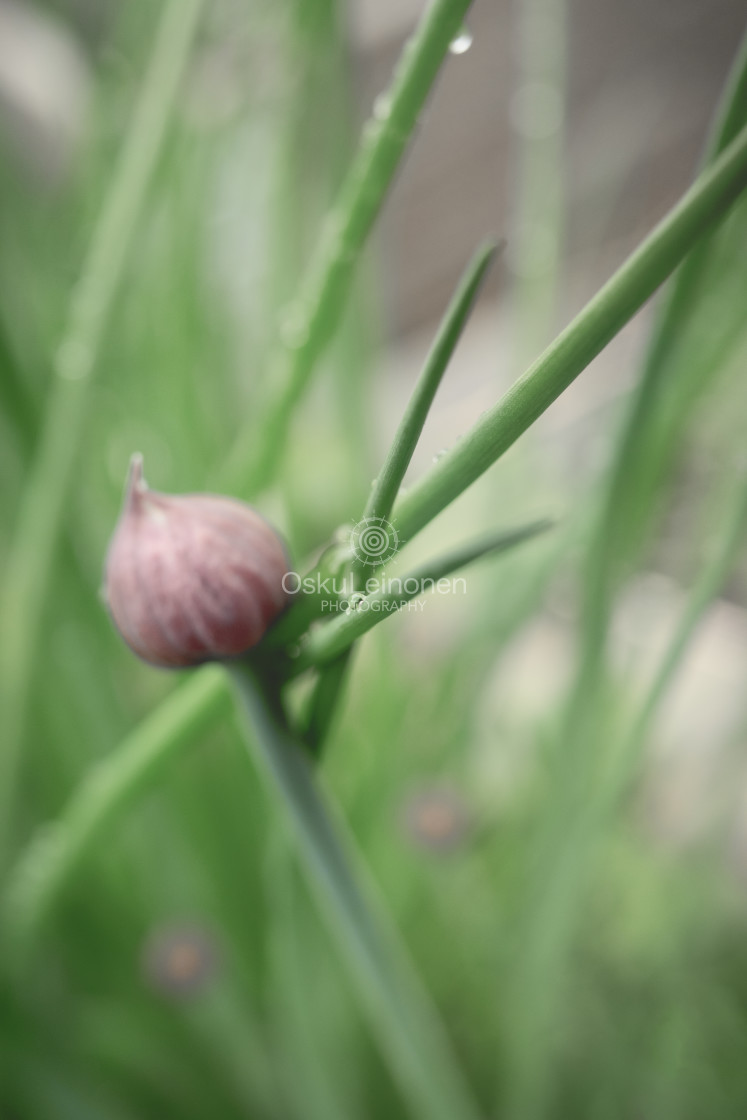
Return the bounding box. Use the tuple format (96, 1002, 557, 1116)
(0, 0, 203, 866)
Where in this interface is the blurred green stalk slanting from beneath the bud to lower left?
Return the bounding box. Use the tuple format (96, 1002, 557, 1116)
(2, 666, 230, 962)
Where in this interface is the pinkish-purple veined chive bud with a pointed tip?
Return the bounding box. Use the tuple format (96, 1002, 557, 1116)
(105, 455, 289, 669)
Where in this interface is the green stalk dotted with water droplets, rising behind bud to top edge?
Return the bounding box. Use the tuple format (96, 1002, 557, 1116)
(222, 0, 471, 493)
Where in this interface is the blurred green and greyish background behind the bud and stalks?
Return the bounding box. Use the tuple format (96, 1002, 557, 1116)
(0, 0, 747, 1120)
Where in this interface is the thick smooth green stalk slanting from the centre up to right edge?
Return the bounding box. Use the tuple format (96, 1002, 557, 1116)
(393, 120, 747, 540)
